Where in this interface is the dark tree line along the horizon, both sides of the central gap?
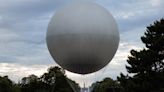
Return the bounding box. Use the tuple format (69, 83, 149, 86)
(0, 19, 164, 92)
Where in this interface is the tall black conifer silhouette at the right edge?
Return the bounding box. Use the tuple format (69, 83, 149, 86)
(118, 19, 164, 92)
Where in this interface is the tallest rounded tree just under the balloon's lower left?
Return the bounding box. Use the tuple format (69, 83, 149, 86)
(45, 67, 73, 92)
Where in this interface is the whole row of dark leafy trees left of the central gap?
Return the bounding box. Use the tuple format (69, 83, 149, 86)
(0, 67, 79, 92)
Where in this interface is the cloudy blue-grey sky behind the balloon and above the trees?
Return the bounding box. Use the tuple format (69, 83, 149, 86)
(0, 0, 164, 85)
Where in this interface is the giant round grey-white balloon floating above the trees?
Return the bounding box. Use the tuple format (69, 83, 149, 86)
(47, 2, 119, 74)
